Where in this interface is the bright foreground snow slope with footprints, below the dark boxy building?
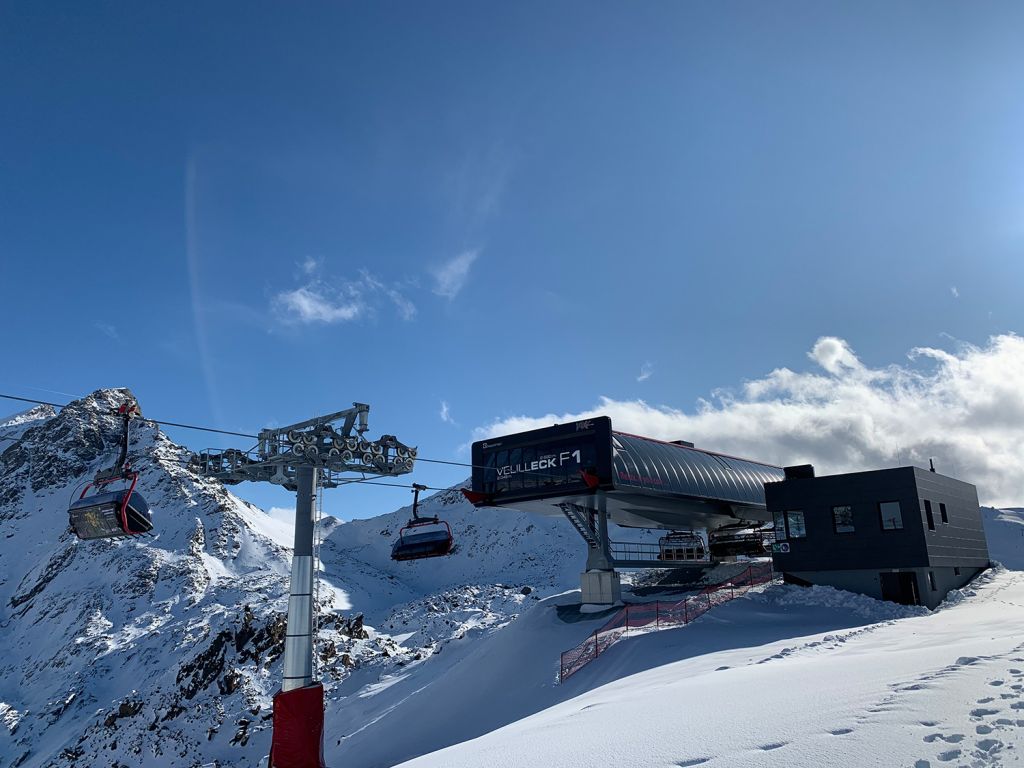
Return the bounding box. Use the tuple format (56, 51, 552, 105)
(395, 510, 1024, 768)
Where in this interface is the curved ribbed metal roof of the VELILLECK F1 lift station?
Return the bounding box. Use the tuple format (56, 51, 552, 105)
(611, 432, 784, 507)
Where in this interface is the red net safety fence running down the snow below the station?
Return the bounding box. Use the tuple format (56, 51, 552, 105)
(558, 562, 774, 681)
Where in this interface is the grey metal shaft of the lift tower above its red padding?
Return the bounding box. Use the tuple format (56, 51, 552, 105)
(282, 465, 317, 691)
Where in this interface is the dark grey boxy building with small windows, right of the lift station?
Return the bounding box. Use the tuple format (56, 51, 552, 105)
(765, 466, 988, 608)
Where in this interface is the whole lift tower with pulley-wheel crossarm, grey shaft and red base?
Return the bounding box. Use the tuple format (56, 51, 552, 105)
(193, 402, 416, 768)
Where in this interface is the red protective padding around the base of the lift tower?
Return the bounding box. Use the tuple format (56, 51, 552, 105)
(270, 683, 325, 768)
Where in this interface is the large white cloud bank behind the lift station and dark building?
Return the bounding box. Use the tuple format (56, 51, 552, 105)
(474, 334, 1024, 506)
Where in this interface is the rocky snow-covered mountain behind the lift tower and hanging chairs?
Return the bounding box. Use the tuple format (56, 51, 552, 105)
(0, 390, 598, 768)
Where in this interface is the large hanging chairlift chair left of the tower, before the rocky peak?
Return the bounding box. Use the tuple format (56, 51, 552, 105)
(68, 401, 153, 541)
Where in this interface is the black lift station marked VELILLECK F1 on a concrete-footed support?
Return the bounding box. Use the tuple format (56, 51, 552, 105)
(465, 417, 784, 603)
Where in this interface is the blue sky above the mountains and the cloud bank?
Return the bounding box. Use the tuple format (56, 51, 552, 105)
(0, 2, 1024, 517)
